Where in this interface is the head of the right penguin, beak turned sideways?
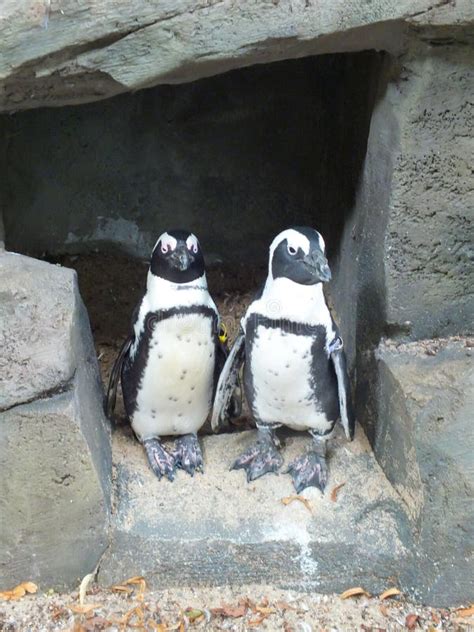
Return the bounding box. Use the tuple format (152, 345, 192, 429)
(269, 226, 331, 285)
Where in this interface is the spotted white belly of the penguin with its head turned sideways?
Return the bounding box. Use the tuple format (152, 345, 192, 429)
(250, 325, 331, 432)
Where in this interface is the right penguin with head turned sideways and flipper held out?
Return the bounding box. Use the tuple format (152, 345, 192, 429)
(211, 227, 355, 493)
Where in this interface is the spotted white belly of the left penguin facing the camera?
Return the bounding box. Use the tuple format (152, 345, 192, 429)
(132, 314, 215, 440)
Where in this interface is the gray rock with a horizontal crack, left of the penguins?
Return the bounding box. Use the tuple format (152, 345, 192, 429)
(0, 253, 111, 588)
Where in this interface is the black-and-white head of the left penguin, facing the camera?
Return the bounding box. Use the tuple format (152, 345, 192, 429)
(150, 230, 204, 283)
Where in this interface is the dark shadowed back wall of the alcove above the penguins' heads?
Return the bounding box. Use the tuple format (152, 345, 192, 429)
(4, 52, 382, 263)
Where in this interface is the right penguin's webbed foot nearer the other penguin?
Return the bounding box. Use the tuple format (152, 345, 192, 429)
(230, 428, 283, 483)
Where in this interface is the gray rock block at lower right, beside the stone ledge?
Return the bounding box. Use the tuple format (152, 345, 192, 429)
(374, 339, 474, 605)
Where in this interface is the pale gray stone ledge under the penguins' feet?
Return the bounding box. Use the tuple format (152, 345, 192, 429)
(99, 428, 410, 592)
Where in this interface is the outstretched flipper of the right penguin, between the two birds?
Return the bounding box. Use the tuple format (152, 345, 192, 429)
(211, 329, 245, 432)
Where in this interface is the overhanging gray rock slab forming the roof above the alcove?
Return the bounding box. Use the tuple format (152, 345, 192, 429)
(0, 0, 473, 110)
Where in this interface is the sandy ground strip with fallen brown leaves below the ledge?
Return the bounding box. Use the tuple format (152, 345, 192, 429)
(0, 579, 474, 632)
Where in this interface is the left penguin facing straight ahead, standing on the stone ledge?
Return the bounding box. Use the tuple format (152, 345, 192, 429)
(106, 230, 235, 481)
